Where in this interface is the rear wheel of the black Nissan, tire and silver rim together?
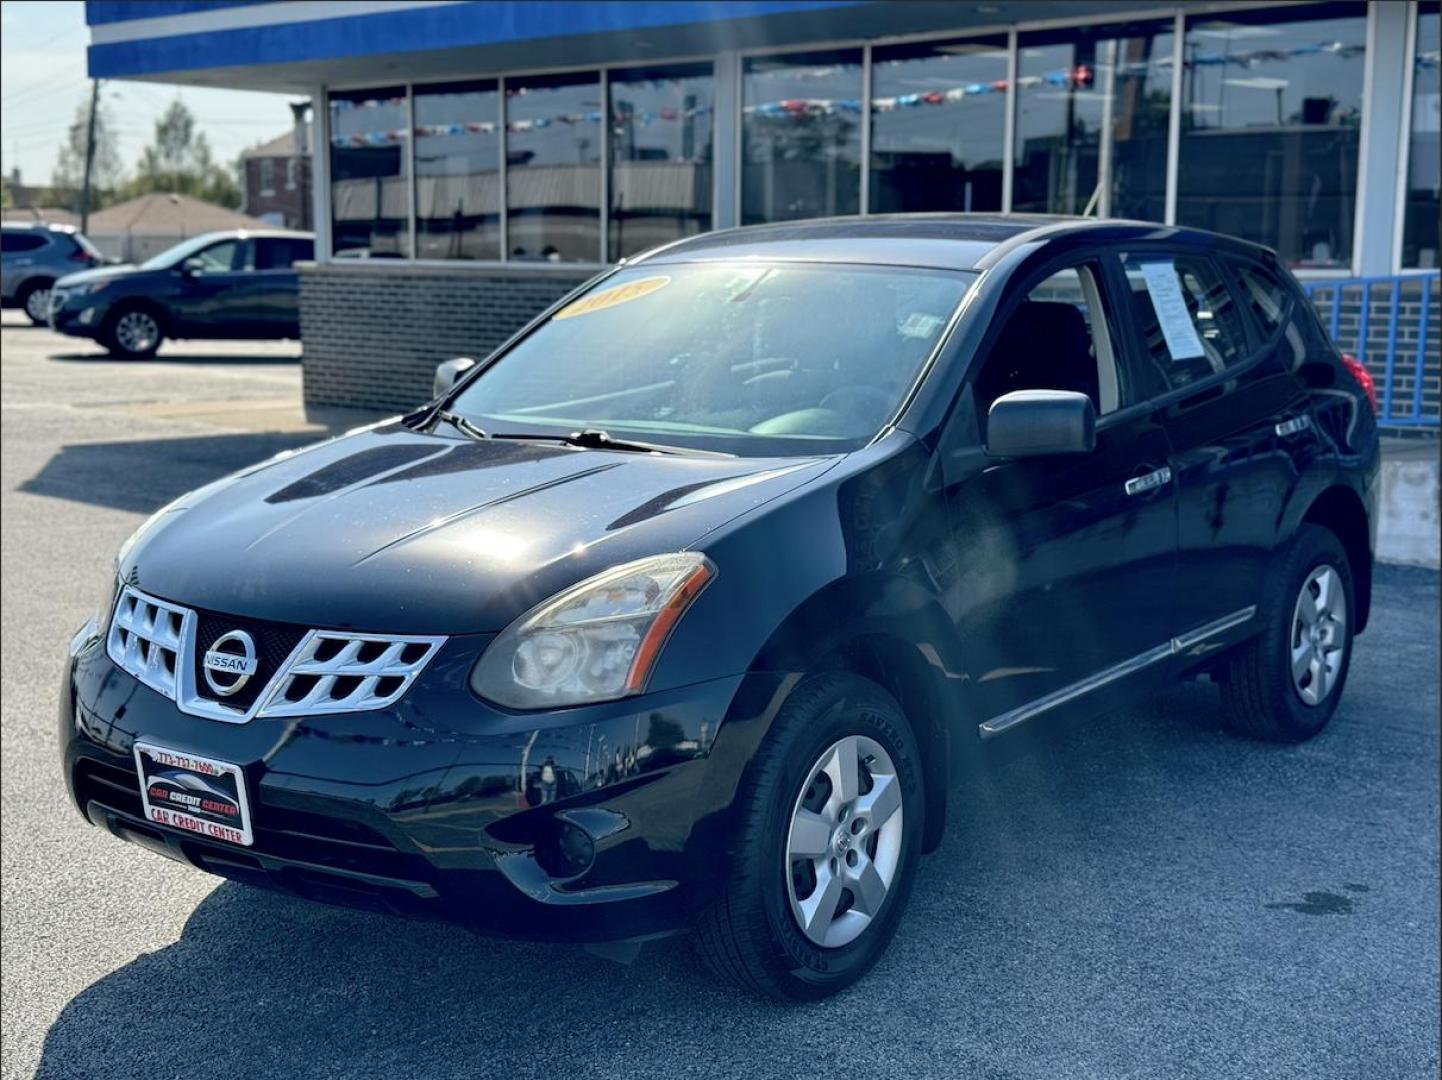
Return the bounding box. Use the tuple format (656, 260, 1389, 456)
(1221, 525, 1357, 743)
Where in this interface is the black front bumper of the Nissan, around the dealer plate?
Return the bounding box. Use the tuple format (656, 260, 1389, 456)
(59, 628, 774, 942)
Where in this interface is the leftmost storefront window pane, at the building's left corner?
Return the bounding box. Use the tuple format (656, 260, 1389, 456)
(329, 87, 411, 257)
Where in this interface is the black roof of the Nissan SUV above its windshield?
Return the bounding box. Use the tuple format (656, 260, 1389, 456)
(634, 213, 1259, 270)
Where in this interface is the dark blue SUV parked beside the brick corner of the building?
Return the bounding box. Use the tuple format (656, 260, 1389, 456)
(49, 231, 314, 359)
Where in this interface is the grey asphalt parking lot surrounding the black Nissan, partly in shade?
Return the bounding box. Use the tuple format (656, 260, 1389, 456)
(0, 313, 1439, 1080)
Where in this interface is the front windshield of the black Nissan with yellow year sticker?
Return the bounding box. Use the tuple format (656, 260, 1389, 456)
(451, 262, 976, 454)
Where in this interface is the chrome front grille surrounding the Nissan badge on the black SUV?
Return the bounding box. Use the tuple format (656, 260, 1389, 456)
(107, 585, 446, 724)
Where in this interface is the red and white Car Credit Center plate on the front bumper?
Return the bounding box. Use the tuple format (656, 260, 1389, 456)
(136, 743, 254, 846)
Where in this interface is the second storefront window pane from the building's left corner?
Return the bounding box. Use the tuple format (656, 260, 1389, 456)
(415, 79, 500, 260)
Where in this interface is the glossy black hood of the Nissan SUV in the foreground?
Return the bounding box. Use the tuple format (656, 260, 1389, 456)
(131, 422, 838, 634)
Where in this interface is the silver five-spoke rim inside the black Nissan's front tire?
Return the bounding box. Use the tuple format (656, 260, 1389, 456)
(786, 735, 903, 949)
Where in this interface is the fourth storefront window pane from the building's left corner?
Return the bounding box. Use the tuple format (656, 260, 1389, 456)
(607, 63, 715, 260)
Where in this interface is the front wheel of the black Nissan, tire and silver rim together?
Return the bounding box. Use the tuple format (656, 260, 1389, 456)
(696, 673, 924, 1001)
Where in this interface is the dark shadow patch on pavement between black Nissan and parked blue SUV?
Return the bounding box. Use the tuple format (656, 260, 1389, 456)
(20, 431, 324, 513)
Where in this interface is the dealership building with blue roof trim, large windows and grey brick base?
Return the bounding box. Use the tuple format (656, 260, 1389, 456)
(87, 0, 1442, 425)
